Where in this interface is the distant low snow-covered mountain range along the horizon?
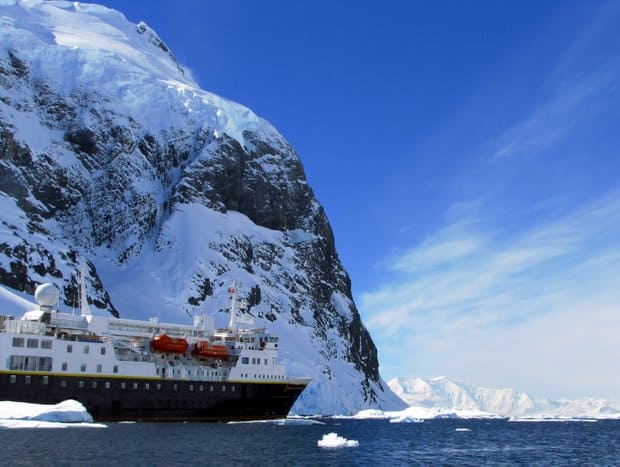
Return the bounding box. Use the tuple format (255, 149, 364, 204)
(388, 376, 620, 419)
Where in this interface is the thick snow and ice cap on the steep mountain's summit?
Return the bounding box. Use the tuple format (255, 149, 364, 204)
(0, 0, 275, 144)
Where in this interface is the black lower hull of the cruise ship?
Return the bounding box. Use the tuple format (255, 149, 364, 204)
(0, 372, 306, 422)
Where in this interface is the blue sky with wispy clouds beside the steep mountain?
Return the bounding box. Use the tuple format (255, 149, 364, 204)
(103, 0, 620, 400)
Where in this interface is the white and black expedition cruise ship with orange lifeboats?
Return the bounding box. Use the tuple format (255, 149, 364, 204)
(0, 283, 310, 421)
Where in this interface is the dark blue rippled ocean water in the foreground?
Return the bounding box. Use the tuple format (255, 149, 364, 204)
(0, 419, 620, 466)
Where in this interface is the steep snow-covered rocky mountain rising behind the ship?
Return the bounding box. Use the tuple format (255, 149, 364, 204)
(0, 0, 402, 413)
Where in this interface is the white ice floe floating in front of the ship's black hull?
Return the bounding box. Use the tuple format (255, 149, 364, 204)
(0, 399, 106, 428)
